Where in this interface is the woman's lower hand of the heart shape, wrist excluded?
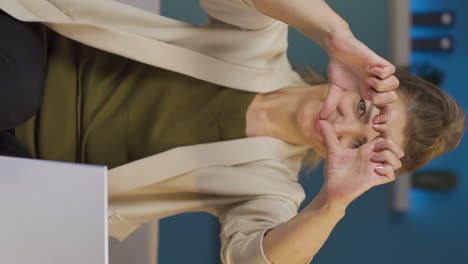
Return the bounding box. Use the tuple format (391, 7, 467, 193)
(320, 120, 403, 207)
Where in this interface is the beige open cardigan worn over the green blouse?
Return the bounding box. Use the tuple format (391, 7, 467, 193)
(0, 0, 312, 264)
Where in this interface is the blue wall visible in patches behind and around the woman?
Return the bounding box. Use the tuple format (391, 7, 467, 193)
(159, 0, 468, 264)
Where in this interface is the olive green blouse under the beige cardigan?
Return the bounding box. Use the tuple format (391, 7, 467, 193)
(15, 30, 255, 168)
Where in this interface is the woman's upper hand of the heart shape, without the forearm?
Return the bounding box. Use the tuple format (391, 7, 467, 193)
(320, 34, 399, 124)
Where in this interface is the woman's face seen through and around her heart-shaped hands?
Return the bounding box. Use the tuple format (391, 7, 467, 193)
(297, 89, 406, 155)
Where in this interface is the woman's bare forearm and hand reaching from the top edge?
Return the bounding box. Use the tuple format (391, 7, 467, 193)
(251, 0, 399, 124)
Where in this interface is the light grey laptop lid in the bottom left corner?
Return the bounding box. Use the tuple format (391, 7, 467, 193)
(0, 156, 108, 264)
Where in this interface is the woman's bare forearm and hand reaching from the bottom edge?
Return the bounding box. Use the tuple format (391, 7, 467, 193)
(263, 121, 403, 264)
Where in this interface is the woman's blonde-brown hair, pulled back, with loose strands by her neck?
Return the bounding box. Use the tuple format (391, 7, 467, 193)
(295, 65, 465, 173)
